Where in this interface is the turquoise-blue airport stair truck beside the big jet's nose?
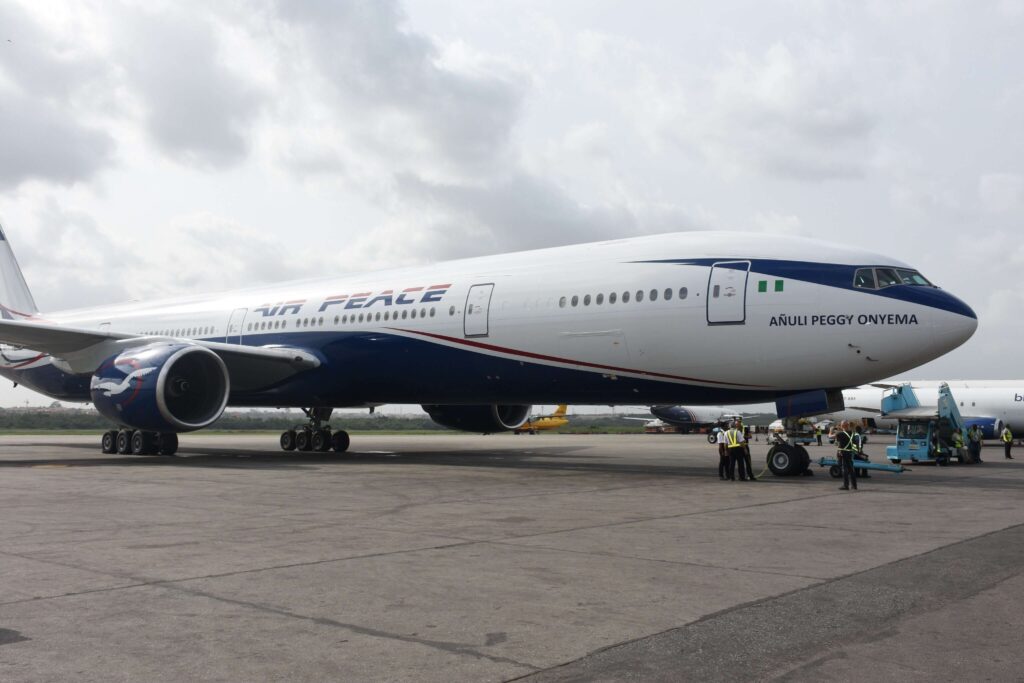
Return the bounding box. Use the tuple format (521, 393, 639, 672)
(882, 383, 968, 465)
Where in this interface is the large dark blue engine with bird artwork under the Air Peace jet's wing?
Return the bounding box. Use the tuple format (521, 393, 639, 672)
(89, 342, 230, 432)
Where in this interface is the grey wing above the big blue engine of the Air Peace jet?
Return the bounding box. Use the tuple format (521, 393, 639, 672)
(0, 321, 321, 391)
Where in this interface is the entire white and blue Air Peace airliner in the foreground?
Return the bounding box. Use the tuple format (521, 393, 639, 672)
(0, 225, 978, 471)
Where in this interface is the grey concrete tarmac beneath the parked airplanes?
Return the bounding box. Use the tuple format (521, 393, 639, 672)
(0, 433, 1024, 682)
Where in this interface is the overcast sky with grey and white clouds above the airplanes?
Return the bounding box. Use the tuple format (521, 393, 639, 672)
(0, 0, 1024, 404)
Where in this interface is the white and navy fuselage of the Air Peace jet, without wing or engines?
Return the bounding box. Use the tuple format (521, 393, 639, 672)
(0, 233, 977, 407)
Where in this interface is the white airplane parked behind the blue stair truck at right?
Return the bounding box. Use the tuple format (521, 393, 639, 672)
(819, 380, 1024, 438)
